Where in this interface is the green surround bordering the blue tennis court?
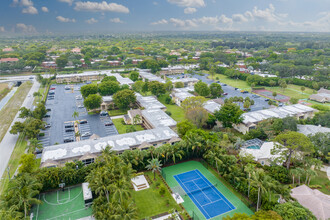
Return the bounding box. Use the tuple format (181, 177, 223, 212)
(161, 161, 253, 220)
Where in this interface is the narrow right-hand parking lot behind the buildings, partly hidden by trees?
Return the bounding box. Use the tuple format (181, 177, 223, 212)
(169, 74, 270, 111)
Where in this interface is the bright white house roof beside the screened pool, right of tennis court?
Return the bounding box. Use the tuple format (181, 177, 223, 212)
(240, 142, 280, 164)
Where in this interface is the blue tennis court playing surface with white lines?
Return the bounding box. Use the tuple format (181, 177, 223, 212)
(174, 169, 235, 219)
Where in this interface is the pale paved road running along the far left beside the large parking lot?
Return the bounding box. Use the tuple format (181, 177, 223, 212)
(0, 81, 40, 177)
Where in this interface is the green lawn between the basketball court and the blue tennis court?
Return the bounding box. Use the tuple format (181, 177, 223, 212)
(132, 172, 182, 219)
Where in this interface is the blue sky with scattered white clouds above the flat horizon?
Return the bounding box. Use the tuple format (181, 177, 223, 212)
(0, 0, 330, 35)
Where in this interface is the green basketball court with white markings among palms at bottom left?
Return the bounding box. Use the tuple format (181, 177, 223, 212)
(31, 186, 92, 220)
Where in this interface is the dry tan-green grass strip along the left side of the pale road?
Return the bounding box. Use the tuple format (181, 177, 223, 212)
(0, 82, 32, 141)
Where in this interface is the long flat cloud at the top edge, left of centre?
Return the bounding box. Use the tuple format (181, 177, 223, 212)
(74, 1, 129, 13)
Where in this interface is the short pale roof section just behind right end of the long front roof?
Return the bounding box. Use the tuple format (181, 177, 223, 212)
(141, 109, 176, 128)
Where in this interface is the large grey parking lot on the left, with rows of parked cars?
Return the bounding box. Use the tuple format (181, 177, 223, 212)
(39, 84, 118, 147)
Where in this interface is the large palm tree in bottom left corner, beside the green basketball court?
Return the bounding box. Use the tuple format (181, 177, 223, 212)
(6, 173, 42, 218)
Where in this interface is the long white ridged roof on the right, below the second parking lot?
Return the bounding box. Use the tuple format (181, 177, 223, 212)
(242, 104, 316, 124)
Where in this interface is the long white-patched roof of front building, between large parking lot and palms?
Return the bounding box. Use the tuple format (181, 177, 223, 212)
(41, 127, 178, 163)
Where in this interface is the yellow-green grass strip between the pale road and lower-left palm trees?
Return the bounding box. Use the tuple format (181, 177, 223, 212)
(0, 134, 27, 195)
